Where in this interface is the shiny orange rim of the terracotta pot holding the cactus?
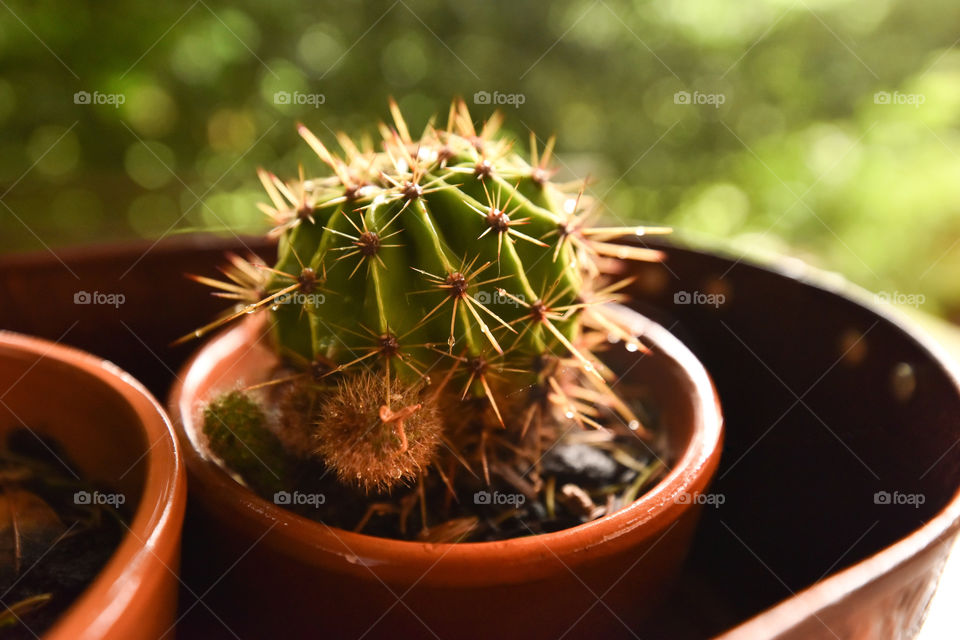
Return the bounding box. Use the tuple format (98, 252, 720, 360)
(168, 305, 723, 569)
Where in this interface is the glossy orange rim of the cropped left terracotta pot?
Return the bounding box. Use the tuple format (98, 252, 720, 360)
(0, 330, 186, 640)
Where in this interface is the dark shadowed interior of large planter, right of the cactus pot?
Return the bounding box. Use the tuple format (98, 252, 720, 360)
(632, 238, 960, 637)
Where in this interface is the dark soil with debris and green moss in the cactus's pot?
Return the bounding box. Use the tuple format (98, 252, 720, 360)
(211, 368, 672, 542)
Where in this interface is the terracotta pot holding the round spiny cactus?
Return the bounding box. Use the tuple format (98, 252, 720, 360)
(170, 309, 722, 638)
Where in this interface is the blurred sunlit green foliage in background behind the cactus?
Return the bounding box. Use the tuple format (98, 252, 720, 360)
(0, 0, 960, 317)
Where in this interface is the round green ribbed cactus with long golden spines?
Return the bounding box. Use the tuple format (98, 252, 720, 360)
(186, 100, 667, 510)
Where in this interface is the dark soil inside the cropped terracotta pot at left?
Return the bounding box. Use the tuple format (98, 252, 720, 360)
(0, 429, 125, 639)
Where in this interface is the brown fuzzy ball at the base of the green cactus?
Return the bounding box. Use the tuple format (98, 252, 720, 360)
(314, 370, 443, 493)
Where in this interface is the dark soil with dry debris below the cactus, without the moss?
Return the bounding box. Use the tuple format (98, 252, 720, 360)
(233, 380, 671, 542)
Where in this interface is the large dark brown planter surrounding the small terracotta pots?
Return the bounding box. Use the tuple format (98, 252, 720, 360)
(0, 236, 960, 640)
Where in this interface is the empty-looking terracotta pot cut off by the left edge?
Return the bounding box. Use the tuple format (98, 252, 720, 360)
(0, 331, 186, 640)
